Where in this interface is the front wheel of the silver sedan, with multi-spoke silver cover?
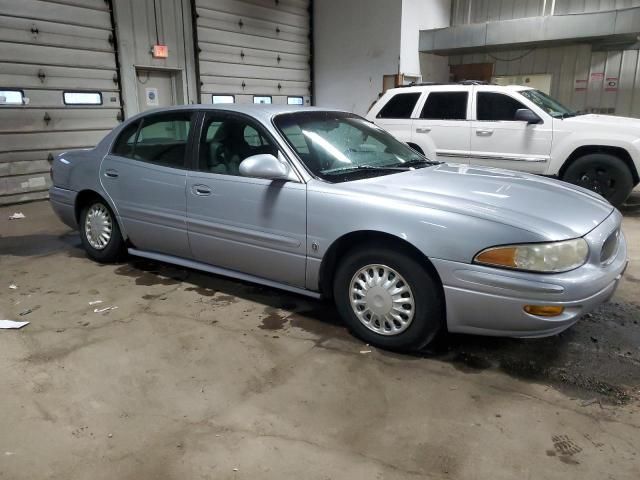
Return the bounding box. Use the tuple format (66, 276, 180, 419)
(333, 246, 445, 351)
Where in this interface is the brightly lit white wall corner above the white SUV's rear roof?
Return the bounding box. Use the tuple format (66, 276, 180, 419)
(400, 0, 451, 76)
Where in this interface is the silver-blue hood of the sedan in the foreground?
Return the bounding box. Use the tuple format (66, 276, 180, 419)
(341, 164, 613, 240)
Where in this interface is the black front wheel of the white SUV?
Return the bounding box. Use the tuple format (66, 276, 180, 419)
(562, 153, 633, 207)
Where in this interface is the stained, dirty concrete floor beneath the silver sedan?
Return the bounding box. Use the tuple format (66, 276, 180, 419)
(0, 194, 640, 480)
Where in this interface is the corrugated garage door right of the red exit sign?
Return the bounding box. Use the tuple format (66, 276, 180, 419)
(195, 0, 311, 105)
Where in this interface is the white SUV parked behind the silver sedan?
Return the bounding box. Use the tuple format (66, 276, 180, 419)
(367, 82, 640, 206)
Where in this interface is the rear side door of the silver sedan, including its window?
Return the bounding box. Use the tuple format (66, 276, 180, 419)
(100, 111, 194, 258)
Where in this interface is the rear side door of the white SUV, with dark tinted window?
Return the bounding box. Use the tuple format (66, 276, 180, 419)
(412, 86, 471, 163)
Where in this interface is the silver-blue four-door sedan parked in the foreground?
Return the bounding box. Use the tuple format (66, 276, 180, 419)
(50, 105, 627, 350)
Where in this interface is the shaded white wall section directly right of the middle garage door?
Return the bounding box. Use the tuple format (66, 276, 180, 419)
(313, 0, 402, 115)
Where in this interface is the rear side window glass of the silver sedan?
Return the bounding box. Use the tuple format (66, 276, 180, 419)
(112, 112, 191, 168)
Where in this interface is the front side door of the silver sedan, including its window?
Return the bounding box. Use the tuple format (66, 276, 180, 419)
(187, 112, 307, 287)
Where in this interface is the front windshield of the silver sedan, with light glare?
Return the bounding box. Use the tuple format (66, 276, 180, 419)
(274, 111, 437, 183)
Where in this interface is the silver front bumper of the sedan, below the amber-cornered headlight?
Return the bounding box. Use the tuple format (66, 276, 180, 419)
(432, 211, 627, 337)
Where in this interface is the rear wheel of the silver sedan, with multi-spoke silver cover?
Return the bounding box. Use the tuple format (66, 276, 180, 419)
(79, 199, 126, 263)
